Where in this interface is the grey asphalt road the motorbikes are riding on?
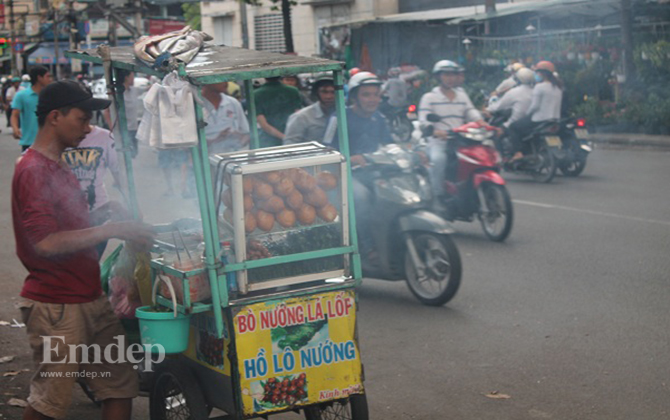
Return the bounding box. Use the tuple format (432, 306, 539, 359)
(0, 135, 670, 420)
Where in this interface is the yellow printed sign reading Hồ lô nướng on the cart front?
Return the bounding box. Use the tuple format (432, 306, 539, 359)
(233, 290, 363, 415)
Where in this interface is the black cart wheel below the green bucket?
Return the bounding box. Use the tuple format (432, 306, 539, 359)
(149, 360, 209, 420)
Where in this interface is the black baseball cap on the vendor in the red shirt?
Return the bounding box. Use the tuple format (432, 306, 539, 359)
(36, 80, 112, 115)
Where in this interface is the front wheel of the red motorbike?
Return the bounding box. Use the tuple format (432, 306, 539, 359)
(479, 182, 514, 242)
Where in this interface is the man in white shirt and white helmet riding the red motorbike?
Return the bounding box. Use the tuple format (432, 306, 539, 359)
(419, 60, 484, 212)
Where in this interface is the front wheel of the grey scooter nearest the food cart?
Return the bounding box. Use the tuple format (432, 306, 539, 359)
(405, 232, 462, 306)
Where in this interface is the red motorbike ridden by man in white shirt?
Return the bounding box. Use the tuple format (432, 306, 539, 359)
(422, 114, 514, 242)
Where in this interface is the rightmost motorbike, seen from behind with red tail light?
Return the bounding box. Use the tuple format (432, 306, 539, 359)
(554, 117, 593, 176)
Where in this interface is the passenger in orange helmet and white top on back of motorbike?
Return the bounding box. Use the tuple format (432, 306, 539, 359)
(509, 61, 563, 161)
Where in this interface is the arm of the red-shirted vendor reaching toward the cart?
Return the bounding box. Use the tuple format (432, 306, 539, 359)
(35, 221, 155, 258)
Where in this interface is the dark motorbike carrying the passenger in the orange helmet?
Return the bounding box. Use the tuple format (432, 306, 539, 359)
(489, 111, 562, 183)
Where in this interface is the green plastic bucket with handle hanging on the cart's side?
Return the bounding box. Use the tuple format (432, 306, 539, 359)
(135, 276, 191, 354)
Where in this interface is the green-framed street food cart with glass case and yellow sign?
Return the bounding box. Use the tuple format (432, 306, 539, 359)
(67, 45, 368, 419)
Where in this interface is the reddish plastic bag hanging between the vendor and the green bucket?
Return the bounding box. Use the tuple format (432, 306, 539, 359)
(108, 243, 151, 319)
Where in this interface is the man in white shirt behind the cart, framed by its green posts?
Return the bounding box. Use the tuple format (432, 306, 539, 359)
(202, 82, 249, 153)
